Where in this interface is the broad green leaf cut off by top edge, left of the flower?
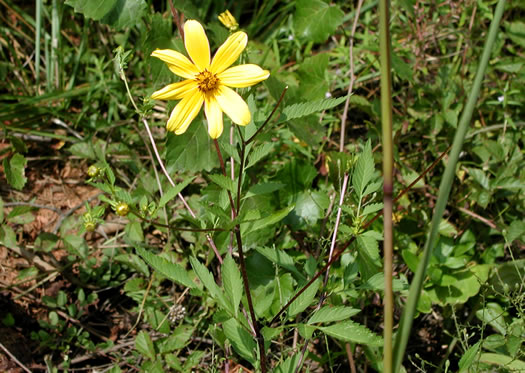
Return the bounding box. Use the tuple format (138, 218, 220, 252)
(66, 0, 147, 30)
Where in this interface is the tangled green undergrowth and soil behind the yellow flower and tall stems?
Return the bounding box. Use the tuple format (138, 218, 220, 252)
(0, 0, 525, 372)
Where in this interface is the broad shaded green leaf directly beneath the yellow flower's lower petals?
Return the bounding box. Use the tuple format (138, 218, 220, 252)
(166, 120, 219, 172)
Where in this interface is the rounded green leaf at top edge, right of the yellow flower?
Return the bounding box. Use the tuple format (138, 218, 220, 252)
(294, 0, 344, 43)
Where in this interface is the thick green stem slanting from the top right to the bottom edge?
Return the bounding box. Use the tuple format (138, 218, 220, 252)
(394, 0, 505, 372)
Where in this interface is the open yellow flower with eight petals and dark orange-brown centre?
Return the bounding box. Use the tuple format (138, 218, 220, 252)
(151, 20, 270, 139)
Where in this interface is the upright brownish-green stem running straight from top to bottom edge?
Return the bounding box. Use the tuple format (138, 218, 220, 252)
(379, 0, 394, 373)
